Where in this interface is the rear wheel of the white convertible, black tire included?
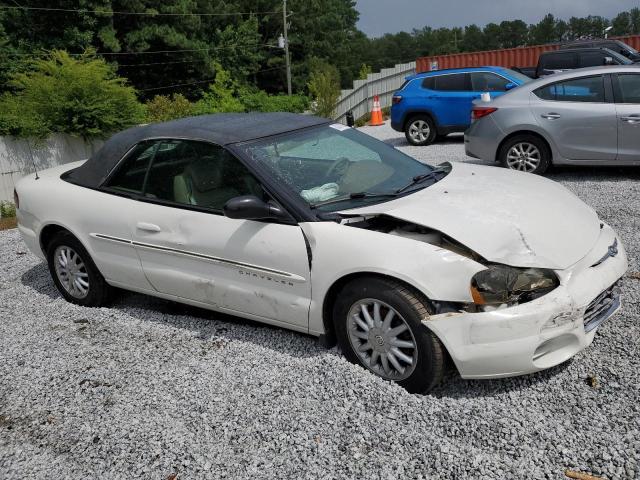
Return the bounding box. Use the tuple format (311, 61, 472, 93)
(46, 231, 112, 307)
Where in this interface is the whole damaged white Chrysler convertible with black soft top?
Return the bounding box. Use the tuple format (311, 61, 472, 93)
(16, 113, 627, 392)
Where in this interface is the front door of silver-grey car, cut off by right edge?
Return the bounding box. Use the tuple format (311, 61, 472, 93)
(613, 73, 640, 162)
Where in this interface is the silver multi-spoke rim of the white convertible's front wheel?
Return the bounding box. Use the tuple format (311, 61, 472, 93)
(347, 298, 418, 382)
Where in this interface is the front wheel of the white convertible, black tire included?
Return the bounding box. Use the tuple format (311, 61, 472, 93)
(333, 277, 445, 393)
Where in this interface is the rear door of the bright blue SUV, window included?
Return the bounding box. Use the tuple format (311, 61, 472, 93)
(427, 73, 480, 127)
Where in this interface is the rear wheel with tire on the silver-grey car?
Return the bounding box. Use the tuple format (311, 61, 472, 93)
(498, 134, 551, 175)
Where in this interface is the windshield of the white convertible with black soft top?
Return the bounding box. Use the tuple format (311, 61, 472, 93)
(239, 124, 446, 212)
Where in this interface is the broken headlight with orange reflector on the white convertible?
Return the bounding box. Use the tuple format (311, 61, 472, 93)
(471, 265, 559, 305)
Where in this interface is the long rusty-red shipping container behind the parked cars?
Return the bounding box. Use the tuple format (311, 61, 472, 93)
(416, 35, 640, 73)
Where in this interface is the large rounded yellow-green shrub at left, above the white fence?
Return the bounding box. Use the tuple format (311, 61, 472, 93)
(0, 50, 144, 138)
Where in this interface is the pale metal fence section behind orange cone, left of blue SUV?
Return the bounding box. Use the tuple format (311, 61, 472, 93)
(334, 62, 416, 123)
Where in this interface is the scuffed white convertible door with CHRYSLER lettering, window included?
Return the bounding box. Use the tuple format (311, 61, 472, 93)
(122, 140, 311, 330)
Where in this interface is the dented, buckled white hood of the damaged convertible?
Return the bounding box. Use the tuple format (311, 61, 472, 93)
(341, 163, 600, 270)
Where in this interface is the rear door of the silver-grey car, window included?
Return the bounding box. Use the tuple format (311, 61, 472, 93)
(530, 75, 618, 160)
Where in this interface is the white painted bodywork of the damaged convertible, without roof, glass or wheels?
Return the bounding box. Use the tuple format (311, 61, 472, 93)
(17, 159, 627, 378)
